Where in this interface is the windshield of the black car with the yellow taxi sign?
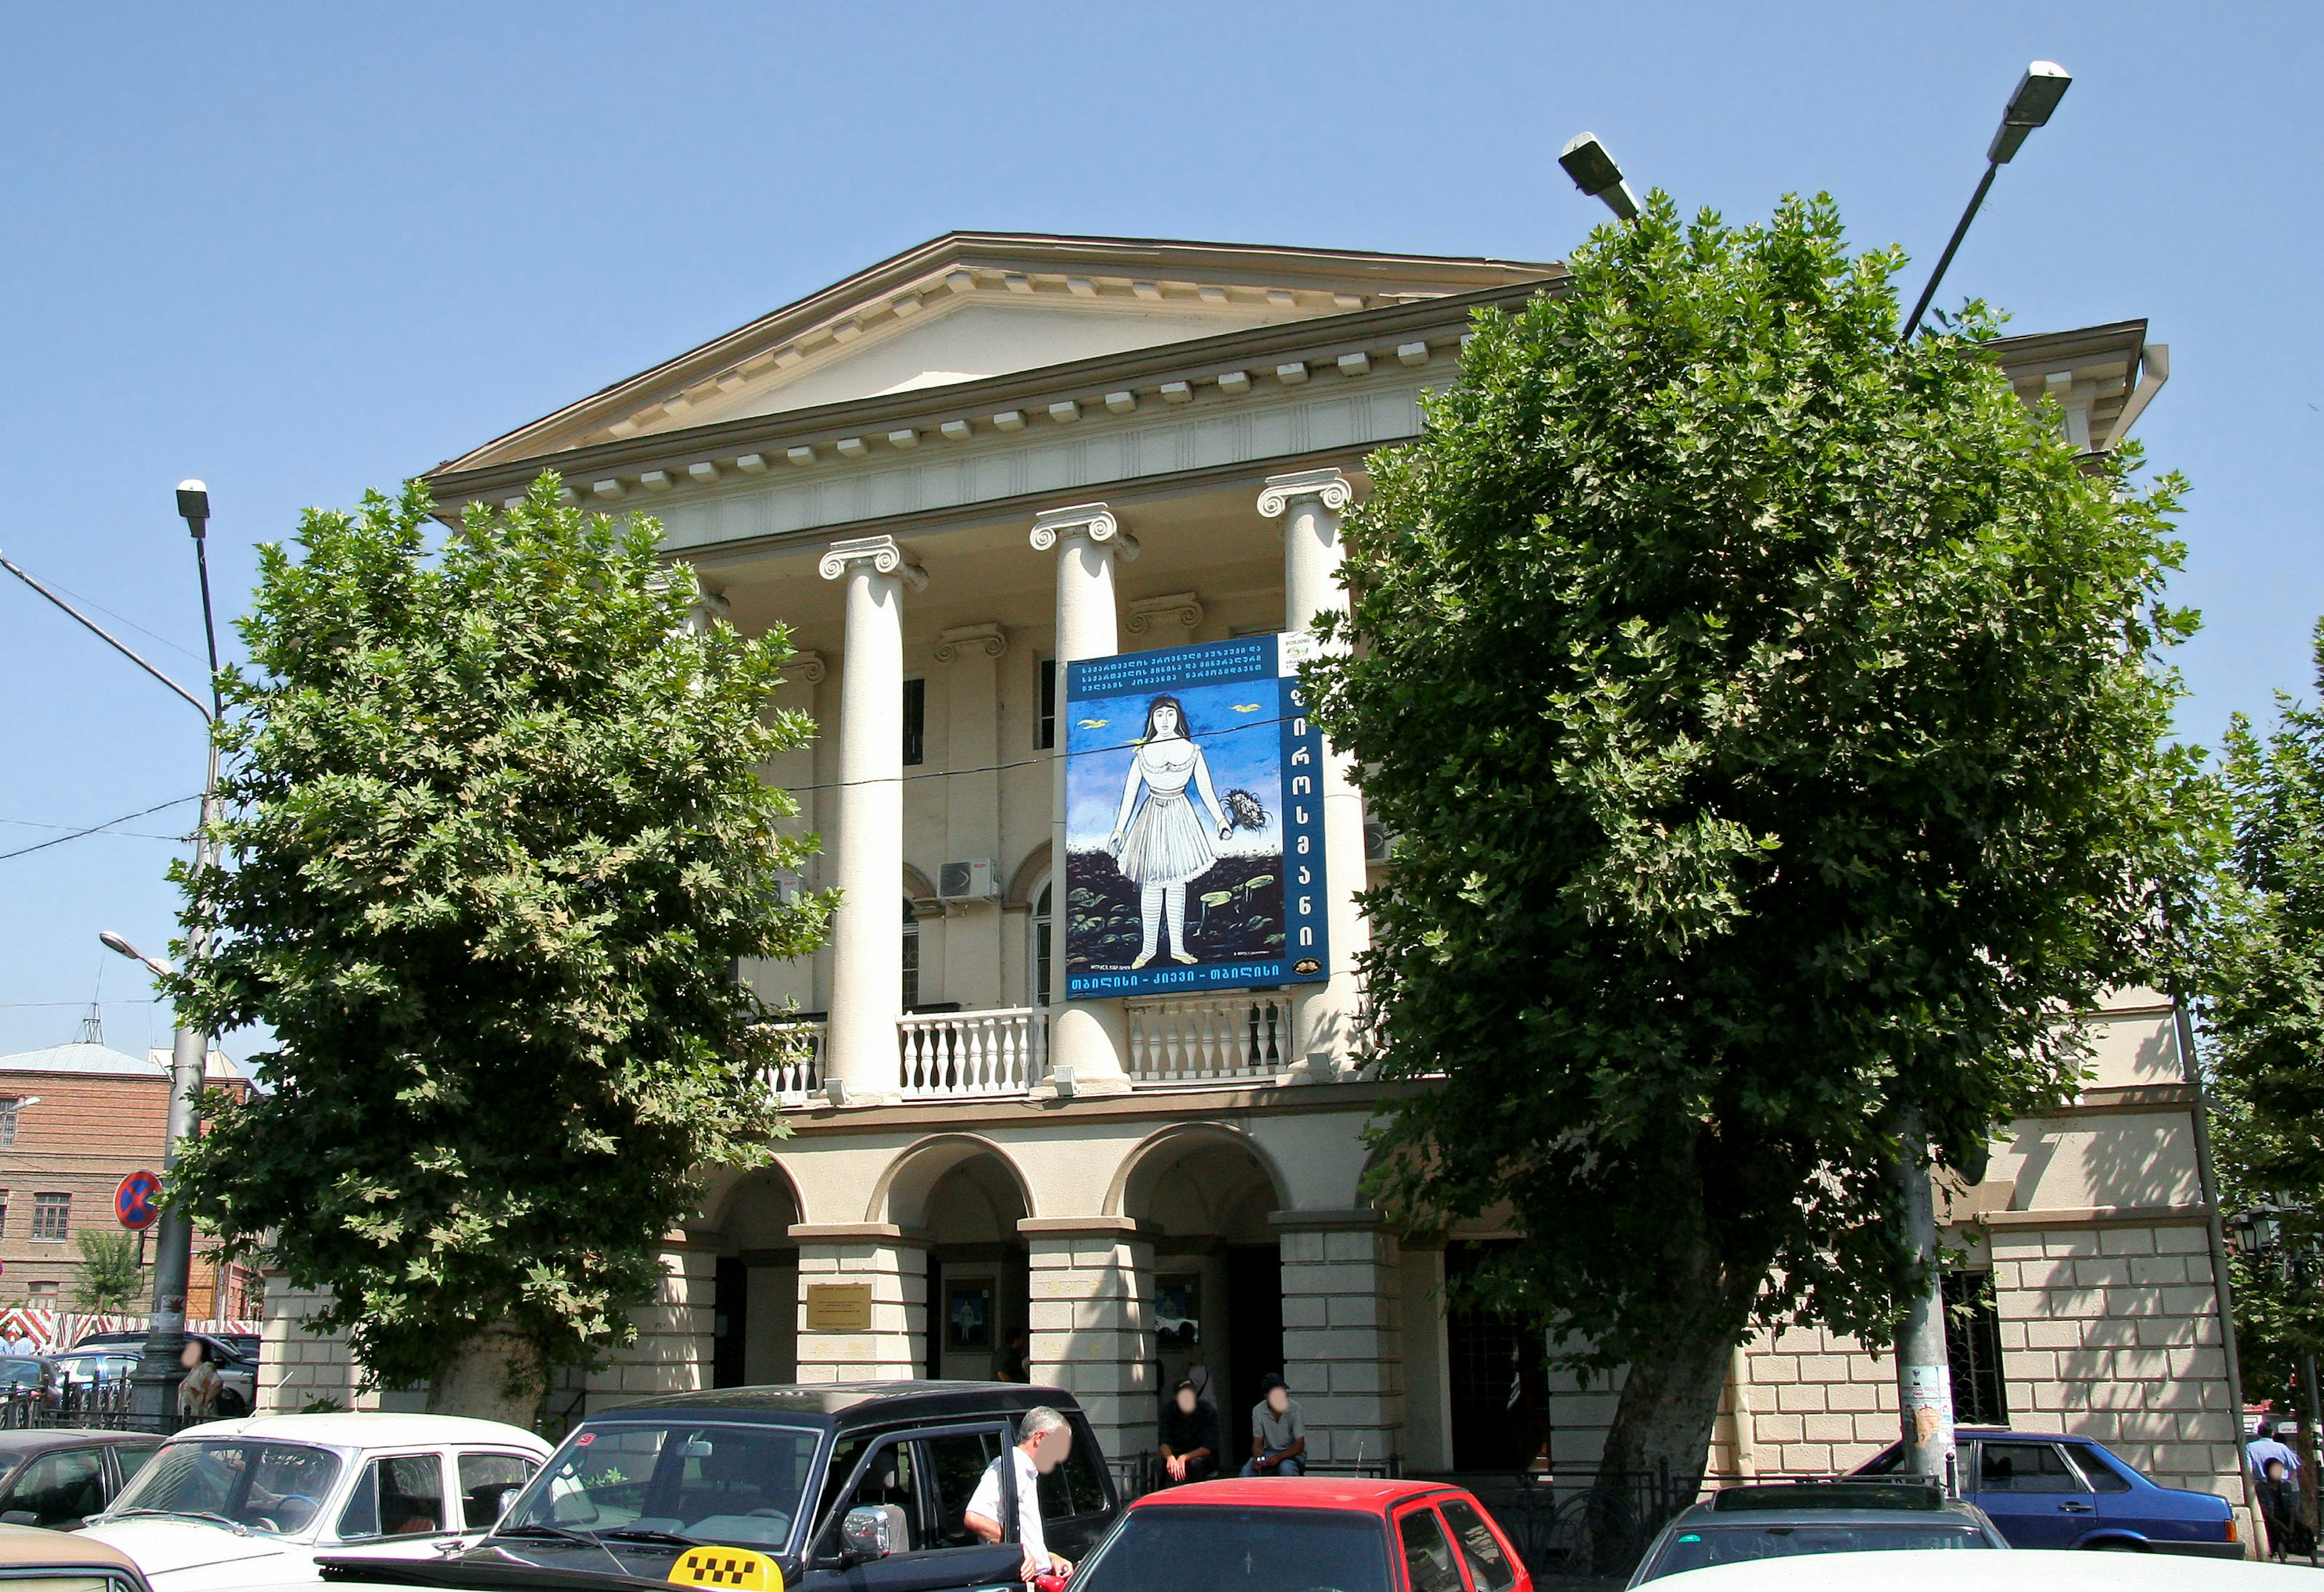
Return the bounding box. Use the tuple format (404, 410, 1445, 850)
(495, 1420, 822, 1548)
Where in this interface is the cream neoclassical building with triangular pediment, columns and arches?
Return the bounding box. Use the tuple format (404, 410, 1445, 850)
(269, 235, 2240, 1524)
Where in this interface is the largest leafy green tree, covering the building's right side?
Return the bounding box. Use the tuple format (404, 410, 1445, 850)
(1308, 196, 2203, 1505)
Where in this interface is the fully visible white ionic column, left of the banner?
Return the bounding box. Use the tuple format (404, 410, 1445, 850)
(821, 537, 927, 1099)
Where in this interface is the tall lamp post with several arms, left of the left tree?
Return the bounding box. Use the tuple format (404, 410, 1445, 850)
(0, 481, 225, 1429)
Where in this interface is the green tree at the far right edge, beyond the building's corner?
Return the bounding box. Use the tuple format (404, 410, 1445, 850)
(2201, 623, 2324, 1396)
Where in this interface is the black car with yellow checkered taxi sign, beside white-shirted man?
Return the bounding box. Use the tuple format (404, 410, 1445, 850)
(326, 1383, 1124, 1592)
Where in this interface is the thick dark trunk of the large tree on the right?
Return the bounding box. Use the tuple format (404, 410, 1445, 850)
(1590, 1237, 1752, 1576)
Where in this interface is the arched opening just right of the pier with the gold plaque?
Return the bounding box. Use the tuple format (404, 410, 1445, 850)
(874, 1134, 1032, 1381)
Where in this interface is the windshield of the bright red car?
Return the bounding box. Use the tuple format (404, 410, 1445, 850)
(1074, 1504, 1394, 1592)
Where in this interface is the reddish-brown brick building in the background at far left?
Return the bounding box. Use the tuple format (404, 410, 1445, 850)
(0, 1022, 258, 1320)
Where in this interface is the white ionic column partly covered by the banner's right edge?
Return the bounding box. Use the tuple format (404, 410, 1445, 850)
(1259, 470, 1371, 1076)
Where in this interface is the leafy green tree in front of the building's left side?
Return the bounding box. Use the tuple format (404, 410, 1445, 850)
(172, 474, 830, 1395)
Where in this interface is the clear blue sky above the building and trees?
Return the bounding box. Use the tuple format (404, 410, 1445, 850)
(0, 0, 2324, 1053)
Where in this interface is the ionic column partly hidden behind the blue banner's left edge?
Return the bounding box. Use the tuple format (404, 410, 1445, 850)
(1032, 502, 1139, 1094)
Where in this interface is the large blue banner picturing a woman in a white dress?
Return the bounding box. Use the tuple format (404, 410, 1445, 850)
(1062, 637, 1331, 999)
